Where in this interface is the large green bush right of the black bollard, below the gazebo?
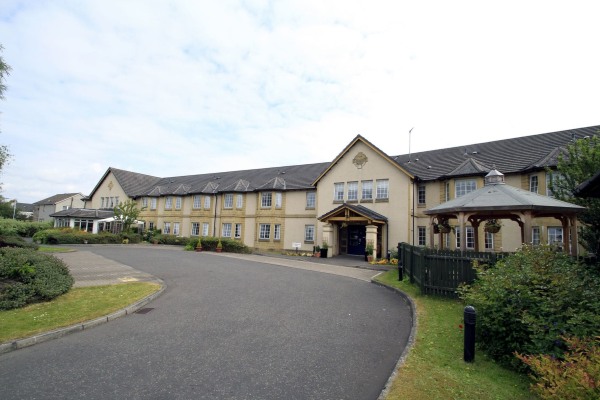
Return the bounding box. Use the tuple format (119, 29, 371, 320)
(459, 246, 600, 369)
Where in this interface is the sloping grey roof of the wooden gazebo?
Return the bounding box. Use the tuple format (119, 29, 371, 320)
(425, 177, 585, 215)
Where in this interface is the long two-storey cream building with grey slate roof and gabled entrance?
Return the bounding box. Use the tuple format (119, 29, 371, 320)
(86, 126, 600, 257)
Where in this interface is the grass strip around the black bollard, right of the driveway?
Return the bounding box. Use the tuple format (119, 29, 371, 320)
(377, 270, 534, 400)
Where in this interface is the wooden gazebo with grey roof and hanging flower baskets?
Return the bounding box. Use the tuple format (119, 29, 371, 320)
(425, 169, 585, 256)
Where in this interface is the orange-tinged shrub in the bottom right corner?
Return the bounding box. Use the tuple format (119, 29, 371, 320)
(517, 336, 600, 399)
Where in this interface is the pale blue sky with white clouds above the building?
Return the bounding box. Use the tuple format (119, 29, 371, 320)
(0, 0, 600, 203)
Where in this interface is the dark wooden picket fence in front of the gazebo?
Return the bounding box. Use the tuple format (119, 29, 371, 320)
(398, 243, 509, 297)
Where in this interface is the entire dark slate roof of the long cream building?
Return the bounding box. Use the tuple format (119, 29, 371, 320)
(94, 125, 600, 198)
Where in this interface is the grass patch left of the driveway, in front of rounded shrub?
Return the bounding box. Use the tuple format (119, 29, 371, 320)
(0, 282, 160, 343)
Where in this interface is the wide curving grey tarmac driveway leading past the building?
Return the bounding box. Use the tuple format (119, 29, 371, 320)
(0, 246, 412, 400)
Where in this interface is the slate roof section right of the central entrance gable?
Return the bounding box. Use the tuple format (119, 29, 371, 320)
(392, 126, 600, 180)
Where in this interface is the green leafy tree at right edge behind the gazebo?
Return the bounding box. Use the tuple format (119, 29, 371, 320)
(548, 136, 600, 255)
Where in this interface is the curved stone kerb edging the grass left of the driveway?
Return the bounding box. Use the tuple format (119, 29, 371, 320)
(0, 279, 166, 355)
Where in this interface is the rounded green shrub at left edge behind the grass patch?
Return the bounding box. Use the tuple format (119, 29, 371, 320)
(0, 247, 73, 310)
